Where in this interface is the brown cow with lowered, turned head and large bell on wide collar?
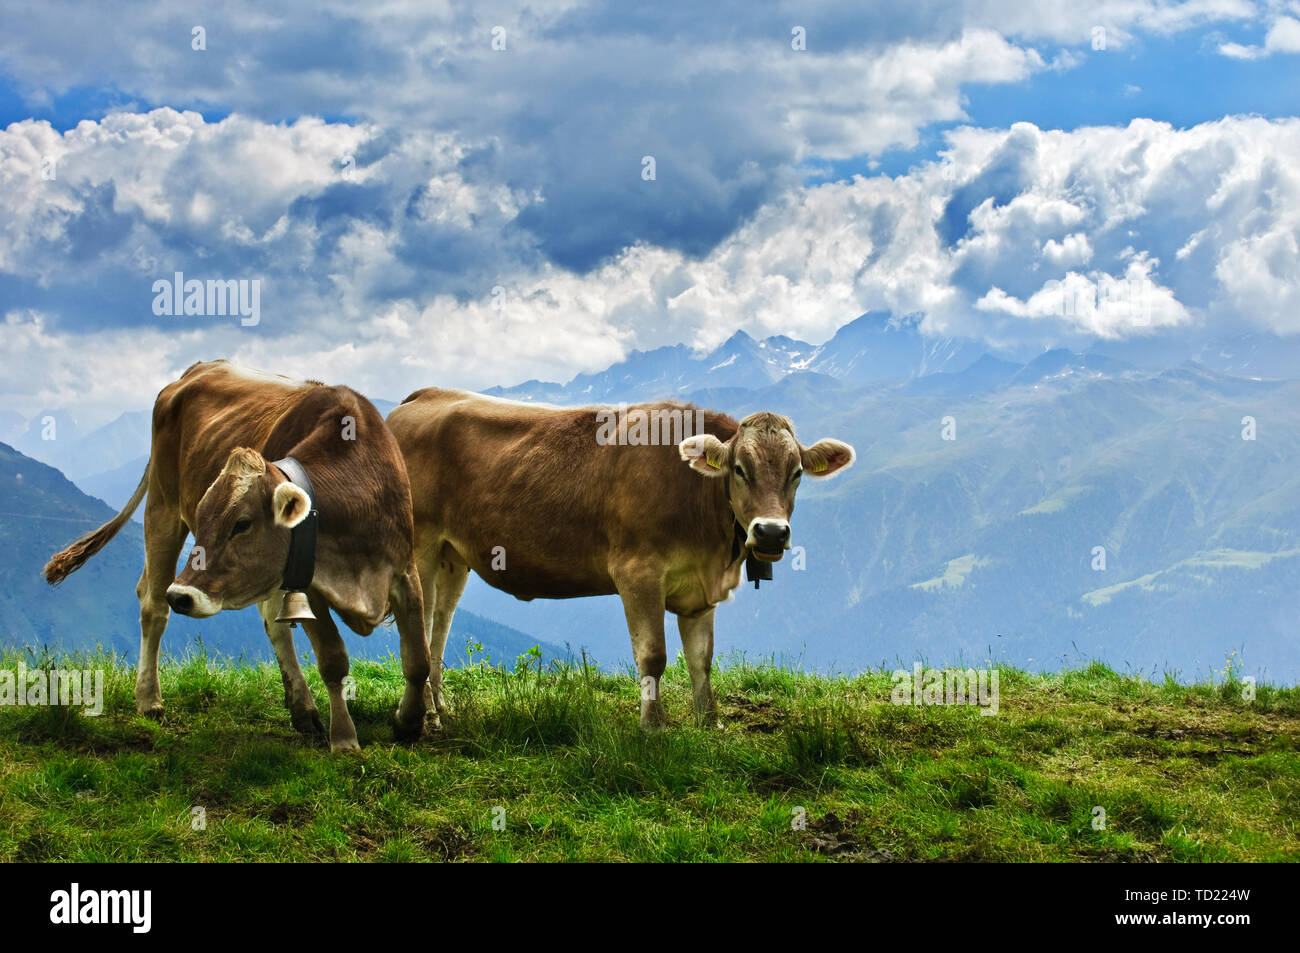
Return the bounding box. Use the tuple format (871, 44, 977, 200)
(44, 360, 429, 750)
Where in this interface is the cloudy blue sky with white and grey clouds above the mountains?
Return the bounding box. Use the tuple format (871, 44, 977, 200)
(0, 0, 1300, 421)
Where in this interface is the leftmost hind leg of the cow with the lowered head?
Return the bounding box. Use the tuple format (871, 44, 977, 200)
(135, 493, 187, 718)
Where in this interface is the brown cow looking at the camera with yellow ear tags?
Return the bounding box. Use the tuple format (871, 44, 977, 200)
(387, 387, 854, 727)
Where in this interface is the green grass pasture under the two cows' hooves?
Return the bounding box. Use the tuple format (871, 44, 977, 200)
(0, 655, 1300, 861)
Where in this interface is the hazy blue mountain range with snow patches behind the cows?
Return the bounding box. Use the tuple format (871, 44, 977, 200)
(0, 312, 1300, 683)
